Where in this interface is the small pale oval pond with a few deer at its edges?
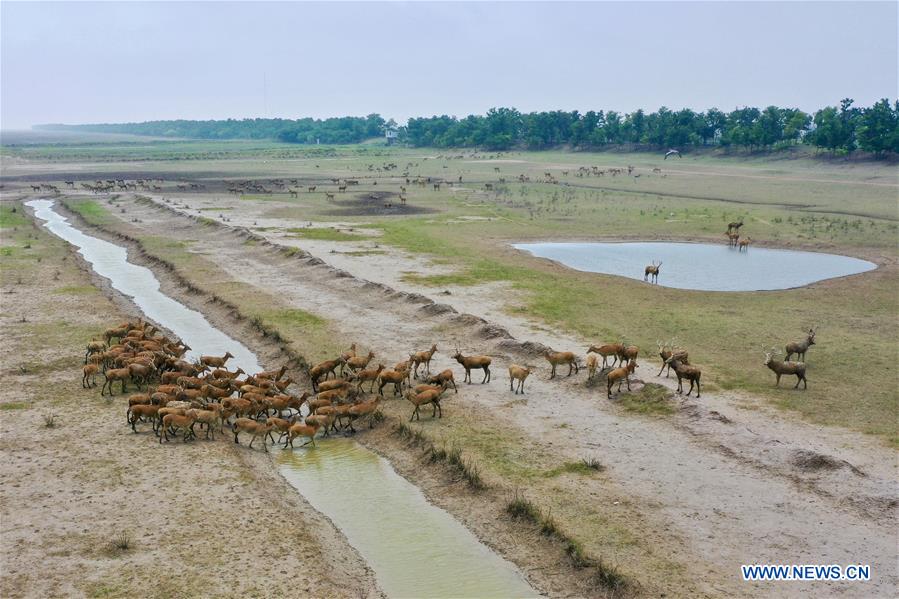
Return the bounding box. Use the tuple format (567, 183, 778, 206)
(514, 242, 877, 291)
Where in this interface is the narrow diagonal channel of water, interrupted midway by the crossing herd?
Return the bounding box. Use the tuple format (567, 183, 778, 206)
(27, 200, 538, 598)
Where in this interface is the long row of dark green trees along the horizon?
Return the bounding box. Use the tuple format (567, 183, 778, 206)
(42, 98, 899, 155)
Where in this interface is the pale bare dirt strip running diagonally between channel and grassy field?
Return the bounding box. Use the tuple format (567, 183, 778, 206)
(105, 195, 897, 596)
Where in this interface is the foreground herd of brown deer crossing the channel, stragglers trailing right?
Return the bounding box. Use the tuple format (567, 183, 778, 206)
(82, 320, 816, 451)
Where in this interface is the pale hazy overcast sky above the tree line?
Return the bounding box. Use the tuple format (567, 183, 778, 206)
(0, 1, 899, 129)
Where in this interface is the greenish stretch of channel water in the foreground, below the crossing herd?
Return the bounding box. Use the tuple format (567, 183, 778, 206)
(276, 438, 537, 599)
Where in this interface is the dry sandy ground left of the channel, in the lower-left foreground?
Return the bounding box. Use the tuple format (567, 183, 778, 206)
(0, 207, 379, 597)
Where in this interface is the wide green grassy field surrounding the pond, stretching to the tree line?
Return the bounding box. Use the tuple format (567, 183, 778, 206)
(4, 142, 899, 446)
